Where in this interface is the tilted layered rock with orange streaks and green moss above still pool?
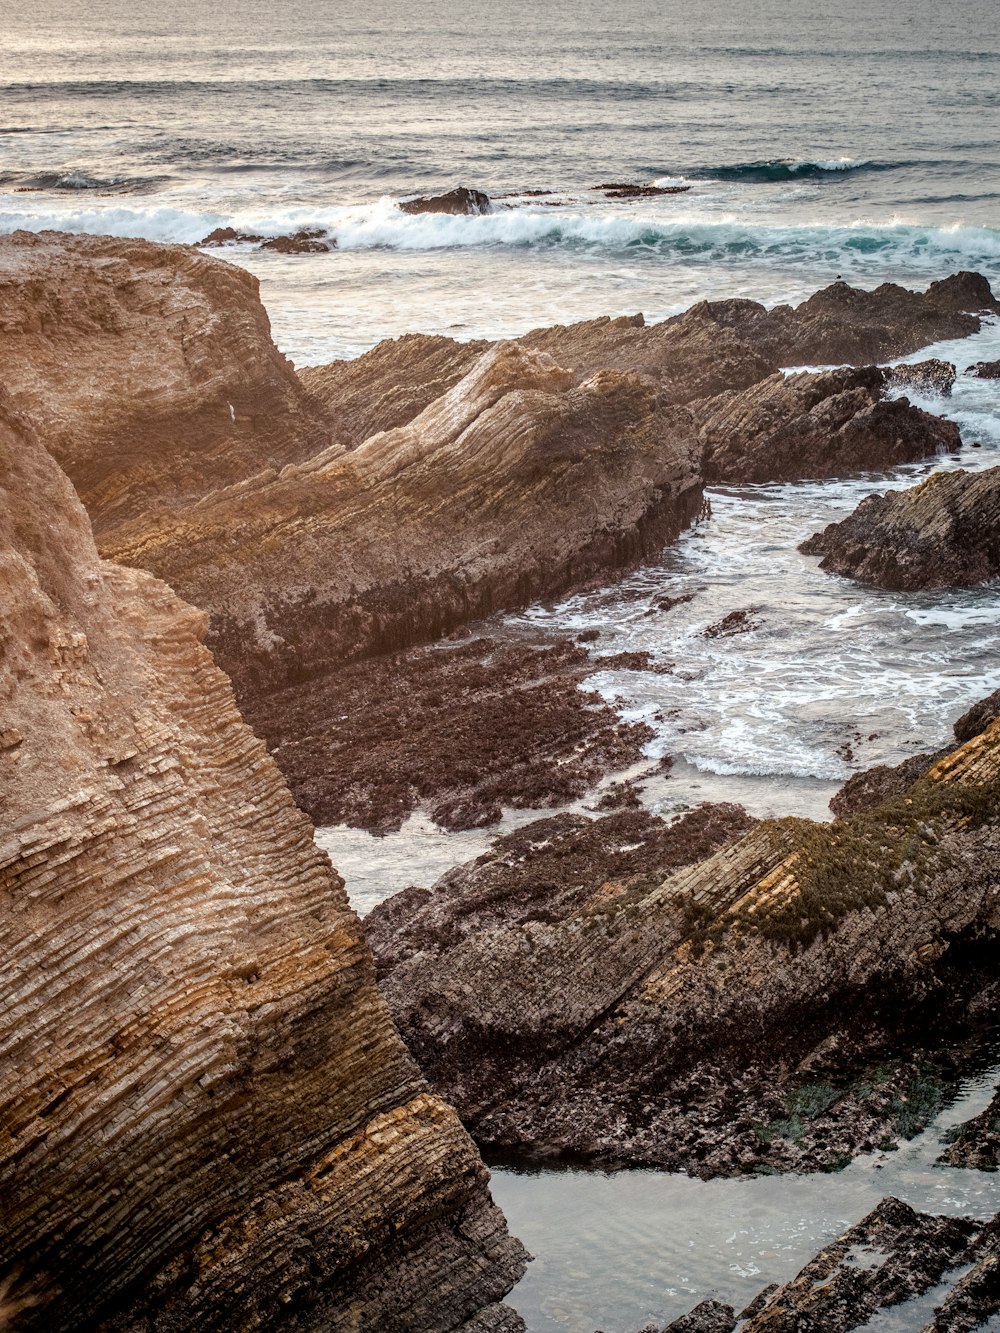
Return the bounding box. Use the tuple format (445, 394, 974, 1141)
(376, 722, 1000, 1174)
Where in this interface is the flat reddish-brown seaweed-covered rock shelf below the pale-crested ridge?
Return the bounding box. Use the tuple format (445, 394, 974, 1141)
(247, 639, 661, 833)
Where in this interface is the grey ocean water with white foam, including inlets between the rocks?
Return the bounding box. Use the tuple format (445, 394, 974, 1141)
(0, 0, 1000, 1333)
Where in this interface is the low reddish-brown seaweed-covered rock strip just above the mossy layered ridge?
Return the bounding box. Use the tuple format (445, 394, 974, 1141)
(365, 802, 755, 974)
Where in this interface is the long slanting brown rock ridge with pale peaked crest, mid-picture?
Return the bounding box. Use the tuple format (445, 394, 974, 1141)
(111, 343, 701, 696)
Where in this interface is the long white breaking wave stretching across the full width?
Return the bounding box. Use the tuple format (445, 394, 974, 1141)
(0, 196, 1000, 275)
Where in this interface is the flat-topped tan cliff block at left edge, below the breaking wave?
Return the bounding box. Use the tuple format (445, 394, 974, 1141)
(0, 232, 336, 530)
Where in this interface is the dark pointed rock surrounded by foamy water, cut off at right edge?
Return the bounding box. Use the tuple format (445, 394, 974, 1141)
(799, 468, 1000, 591)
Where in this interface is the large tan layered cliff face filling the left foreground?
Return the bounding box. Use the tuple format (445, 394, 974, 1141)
(0, 397, 524, 1333)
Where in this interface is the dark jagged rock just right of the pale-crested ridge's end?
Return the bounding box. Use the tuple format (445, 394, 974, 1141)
(697, 365, 961, 483)
